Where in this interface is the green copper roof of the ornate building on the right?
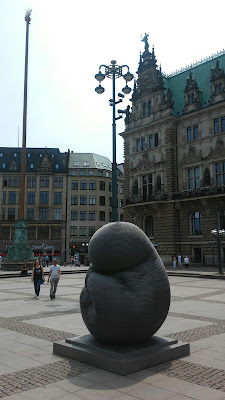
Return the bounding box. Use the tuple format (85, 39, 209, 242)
(163, 52, 225, 116)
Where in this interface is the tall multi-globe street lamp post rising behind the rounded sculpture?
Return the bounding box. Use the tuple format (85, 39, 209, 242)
(95, 60, 133, 222)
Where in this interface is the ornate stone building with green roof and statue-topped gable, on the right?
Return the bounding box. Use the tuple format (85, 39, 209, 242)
(122, 35, 225, 263)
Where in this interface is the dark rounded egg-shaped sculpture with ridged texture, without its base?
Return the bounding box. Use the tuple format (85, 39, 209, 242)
(80, 222, 170, 345)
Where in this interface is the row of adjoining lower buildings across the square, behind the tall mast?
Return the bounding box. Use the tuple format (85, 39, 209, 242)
(0, 147, 124, 262)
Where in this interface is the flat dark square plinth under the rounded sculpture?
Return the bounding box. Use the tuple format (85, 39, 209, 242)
(53, 334, 190, 375)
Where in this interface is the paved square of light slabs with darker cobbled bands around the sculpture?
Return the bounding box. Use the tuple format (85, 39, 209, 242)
(0, 273, 225, 400)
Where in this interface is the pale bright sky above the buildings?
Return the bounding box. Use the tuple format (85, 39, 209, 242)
(0, 0, 225, 163)
